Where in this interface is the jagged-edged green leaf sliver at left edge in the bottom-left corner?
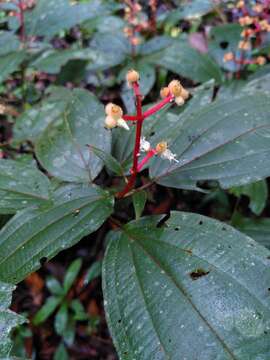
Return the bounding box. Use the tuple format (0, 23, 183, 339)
(0, 282, 25, 359)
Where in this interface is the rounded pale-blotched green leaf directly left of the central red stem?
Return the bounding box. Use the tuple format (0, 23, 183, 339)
(36, 89, 111, 182)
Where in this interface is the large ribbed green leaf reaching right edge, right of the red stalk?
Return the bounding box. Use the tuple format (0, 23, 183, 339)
(150, 94, 270, 188)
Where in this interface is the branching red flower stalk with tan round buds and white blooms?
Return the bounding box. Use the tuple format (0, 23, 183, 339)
(105, 70, 189, 198)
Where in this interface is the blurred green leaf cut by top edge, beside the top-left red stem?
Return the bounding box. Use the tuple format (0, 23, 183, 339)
(25, 0, 114, 39)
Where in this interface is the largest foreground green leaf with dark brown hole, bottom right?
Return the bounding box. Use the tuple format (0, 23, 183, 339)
(103, 212, 270, 360)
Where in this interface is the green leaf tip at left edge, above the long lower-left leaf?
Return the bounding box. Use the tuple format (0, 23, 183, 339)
(0, 159, 50, 214)
